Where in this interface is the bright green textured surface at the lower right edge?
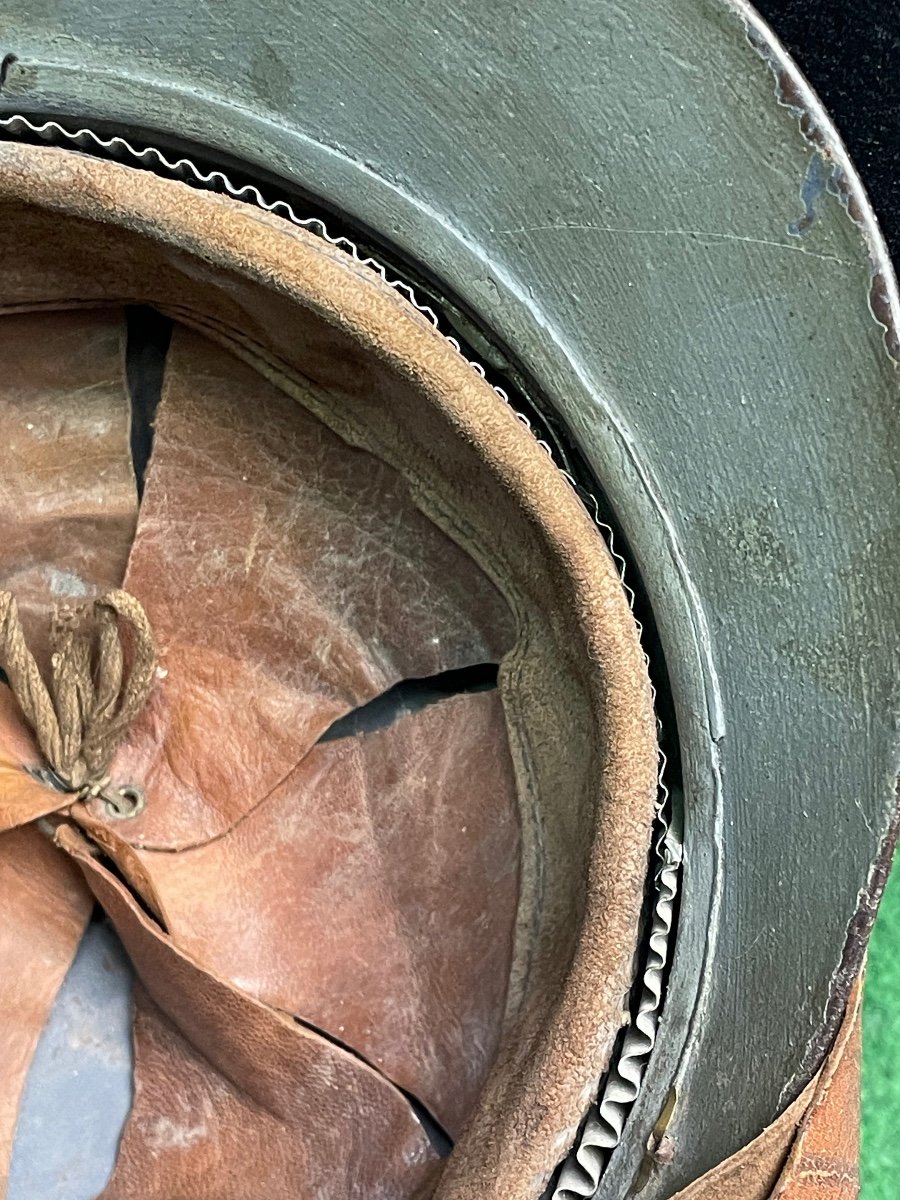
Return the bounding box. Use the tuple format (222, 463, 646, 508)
(859, 868, 900, 1200)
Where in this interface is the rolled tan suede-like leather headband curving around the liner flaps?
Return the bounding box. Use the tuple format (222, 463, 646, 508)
(0, 145, 656, 1200)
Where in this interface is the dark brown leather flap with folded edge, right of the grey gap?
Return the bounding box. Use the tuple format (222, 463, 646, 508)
(58, 826, 438, 1200)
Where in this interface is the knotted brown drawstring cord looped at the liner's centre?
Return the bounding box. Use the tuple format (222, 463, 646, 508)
(0, 590, 156, 816)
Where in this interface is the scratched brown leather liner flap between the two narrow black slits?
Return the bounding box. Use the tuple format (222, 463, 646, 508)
(95, 328, 515, 848)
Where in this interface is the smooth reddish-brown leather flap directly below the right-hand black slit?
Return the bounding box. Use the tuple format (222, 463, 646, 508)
(82, 691, 528, 1136)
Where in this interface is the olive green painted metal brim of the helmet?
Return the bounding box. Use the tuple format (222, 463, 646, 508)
(0, 0, 900, 1200)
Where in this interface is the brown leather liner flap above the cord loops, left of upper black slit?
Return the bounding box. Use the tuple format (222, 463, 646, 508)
(0, 310, 138, 668)
